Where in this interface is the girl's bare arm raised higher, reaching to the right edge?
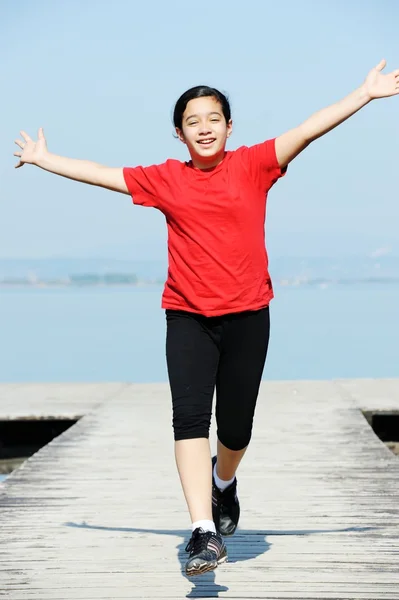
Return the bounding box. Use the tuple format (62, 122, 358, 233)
(276, 60, 399, 168)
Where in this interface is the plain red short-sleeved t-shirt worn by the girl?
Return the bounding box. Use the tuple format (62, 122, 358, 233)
(123, 139, 284, 316)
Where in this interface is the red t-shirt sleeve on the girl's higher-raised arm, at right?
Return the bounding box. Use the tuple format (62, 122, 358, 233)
(243, 138, 287, 192)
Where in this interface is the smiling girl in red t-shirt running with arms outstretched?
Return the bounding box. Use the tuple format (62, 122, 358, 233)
(15, 60, 399, 575)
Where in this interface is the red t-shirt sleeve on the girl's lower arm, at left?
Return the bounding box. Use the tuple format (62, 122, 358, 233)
(123, 164, 166, 210)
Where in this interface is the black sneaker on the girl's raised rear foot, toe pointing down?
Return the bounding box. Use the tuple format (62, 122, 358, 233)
(212, 456, 240, 537)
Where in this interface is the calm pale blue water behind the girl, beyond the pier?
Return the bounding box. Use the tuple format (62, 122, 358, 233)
(0, 284, 399, 382)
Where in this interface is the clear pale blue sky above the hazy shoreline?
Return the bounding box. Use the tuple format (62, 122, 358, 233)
(0, 0, 399, 260)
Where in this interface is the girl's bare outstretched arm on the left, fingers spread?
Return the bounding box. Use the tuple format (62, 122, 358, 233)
(14, 129, 129, 194)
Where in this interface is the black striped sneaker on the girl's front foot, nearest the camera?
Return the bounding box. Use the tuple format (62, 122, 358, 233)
(186, 527, 227, 577)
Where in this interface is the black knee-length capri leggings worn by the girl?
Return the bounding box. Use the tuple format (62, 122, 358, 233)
(166, 307, 270, 450)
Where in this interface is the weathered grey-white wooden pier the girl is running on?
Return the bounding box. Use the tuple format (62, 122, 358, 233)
(0, 380, 399, 600)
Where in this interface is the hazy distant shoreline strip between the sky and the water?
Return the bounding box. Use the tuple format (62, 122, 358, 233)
(0, 254, 399, 290)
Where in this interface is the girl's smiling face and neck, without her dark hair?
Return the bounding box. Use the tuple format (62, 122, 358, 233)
(176, 96, 232, 169)
